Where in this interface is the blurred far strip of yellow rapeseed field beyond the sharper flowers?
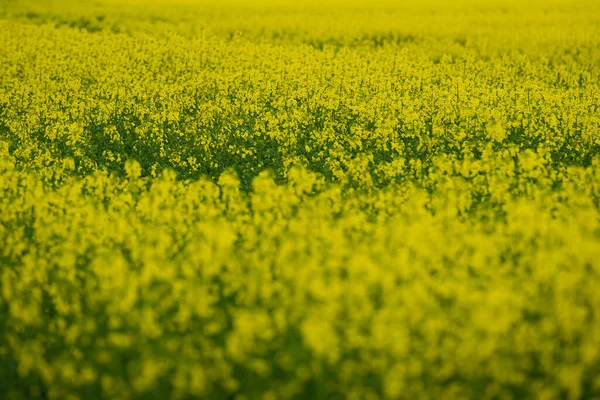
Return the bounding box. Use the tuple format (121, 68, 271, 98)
(0, 0, 600, 59)
